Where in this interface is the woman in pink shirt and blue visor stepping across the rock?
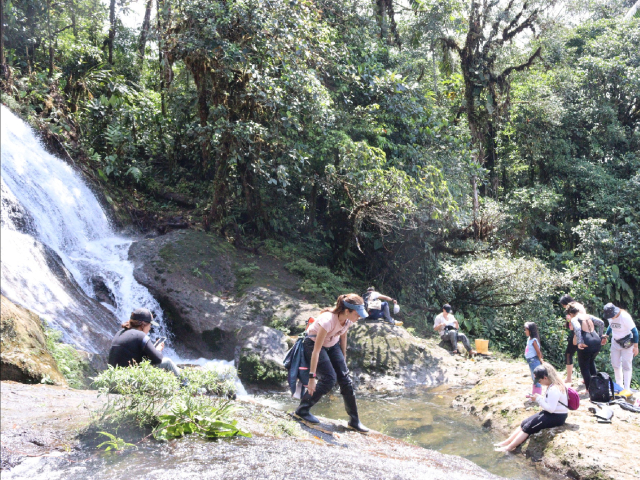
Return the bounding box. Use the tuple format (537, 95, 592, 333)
(295, 293, 369, 433)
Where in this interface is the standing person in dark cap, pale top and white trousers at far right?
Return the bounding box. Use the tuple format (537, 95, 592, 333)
(603, 303, 638, 390)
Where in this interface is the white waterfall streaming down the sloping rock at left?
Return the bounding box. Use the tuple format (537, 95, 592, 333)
(1, 105, 167, 354)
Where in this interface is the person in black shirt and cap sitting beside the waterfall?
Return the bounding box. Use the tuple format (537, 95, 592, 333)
(108, 308, 180, 378)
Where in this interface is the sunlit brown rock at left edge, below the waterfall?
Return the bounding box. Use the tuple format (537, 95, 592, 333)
(0, 296, 66, 385)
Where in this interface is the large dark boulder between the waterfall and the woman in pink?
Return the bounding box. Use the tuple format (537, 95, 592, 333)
(129, 230, 304, 384)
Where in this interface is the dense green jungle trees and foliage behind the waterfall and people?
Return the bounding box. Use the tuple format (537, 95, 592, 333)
(0, 0, 640, 378)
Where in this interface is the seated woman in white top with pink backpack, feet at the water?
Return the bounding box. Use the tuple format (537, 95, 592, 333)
(495, 362, 569, 452)
